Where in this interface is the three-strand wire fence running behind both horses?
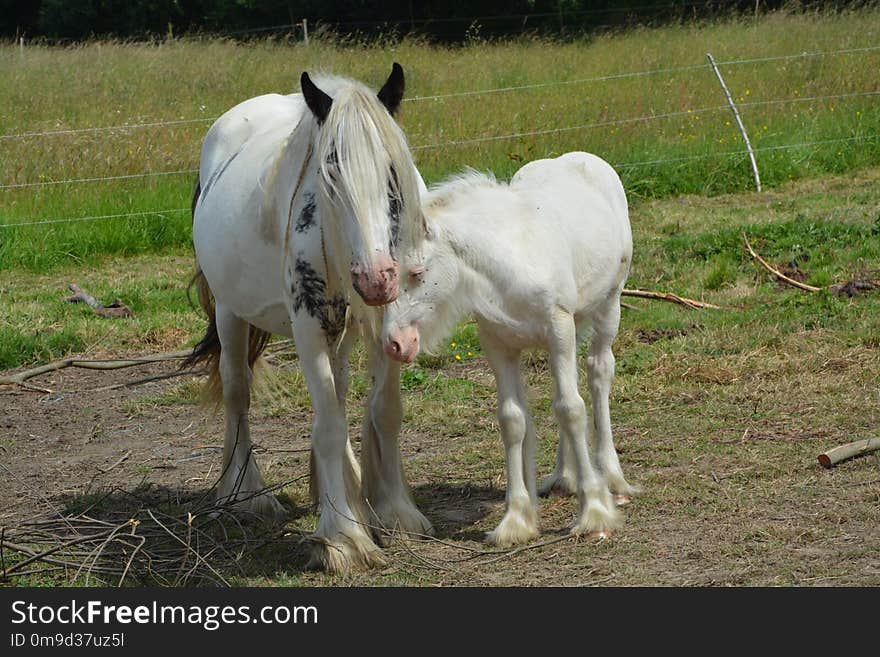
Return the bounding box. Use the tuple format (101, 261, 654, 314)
(0, 46, 880, 229)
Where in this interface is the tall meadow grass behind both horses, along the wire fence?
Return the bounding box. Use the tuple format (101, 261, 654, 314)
(0, 9, 880, 270)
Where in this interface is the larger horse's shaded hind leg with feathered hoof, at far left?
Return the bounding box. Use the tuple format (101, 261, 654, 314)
(216, 305, 285, 520)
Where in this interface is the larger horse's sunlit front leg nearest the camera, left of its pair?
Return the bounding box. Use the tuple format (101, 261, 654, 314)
(293, 310, 384, 573)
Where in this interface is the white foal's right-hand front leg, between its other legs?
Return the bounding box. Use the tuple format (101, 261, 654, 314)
(549, 311, 620, 535)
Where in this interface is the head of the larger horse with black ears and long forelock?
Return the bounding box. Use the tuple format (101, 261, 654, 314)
(301, 63, 423, 306)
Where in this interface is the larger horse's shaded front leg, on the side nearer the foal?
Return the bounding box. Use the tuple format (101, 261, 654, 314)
(361, 341, 434, 534)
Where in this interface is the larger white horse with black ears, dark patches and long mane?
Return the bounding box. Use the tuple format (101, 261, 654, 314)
(190, 64, 431, 571)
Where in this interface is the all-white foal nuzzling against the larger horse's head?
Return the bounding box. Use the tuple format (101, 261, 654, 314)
(383, 152, 634, 546)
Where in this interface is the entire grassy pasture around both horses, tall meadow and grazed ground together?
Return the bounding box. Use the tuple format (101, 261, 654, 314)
(0, 10, 880, 586)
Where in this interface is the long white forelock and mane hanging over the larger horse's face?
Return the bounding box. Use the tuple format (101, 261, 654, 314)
(316, 78, 424, 253)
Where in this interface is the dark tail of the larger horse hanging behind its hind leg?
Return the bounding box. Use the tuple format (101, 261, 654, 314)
(180, 178, 272, 405)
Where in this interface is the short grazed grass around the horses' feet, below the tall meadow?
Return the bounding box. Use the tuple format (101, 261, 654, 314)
(0, 169, 880, 586)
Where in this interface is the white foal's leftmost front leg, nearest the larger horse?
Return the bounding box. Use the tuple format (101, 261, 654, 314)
(480, 331, 539, 547)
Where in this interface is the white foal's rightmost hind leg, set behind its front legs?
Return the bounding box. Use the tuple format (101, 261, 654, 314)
(587, 296, 637, 504)
